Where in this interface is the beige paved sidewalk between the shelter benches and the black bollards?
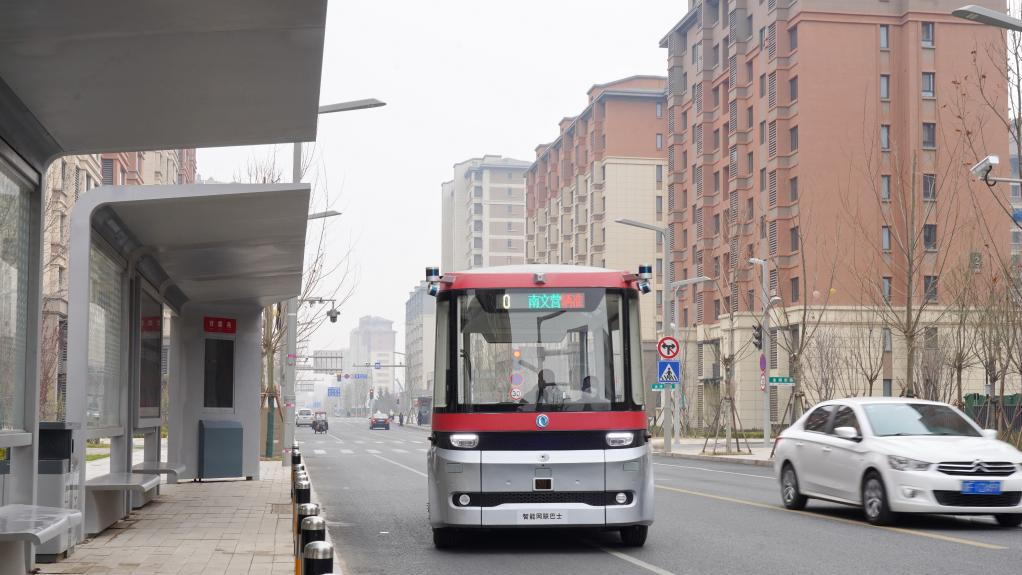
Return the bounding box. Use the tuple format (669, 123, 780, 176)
(38, 462, 340, 575)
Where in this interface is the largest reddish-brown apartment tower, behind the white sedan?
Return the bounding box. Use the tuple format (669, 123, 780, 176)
(660, 0, 1010, 427)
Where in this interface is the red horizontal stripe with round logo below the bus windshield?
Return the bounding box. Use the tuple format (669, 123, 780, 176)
(432, 412, 646, 431)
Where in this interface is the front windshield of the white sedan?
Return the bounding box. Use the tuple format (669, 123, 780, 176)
(863, 403, 981, 437)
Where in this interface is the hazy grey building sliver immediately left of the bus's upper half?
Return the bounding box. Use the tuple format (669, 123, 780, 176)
(405, 281, 436, 399)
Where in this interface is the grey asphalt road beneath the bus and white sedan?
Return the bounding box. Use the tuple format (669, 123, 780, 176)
(297, 419, 1022, 575)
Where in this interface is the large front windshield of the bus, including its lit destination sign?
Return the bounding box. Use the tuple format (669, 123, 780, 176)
(452, 289, 642, 412)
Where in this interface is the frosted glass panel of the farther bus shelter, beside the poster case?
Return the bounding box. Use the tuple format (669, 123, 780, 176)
(85, 246, 124, 429)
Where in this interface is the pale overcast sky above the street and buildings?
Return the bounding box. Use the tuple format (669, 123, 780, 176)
(198, 0, 687, 359)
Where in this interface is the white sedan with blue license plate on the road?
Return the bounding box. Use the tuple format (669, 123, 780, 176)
(774, 397, 1022, 527)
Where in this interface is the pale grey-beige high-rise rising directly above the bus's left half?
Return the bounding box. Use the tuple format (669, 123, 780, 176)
(440, 155, 528, 272)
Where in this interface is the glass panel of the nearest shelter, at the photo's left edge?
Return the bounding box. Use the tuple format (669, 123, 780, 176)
(0, 160, 32, 431)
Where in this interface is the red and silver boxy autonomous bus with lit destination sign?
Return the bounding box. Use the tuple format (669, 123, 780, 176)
(426, 266, 653, 547)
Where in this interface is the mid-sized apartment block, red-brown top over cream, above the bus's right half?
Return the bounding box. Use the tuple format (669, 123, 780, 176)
(525, 76, 667, 340)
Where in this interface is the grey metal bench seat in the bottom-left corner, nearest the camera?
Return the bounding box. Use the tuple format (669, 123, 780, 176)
(0, 505, 82, 575)
